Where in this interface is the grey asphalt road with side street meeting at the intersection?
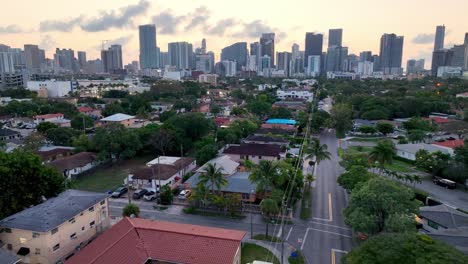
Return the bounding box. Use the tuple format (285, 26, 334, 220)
(109, 131, 353, 264)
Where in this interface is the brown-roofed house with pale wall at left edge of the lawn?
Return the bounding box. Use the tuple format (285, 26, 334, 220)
(49, 152, 98, 179)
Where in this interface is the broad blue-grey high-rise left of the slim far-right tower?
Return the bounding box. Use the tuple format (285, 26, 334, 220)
(380, 33, 403, 75)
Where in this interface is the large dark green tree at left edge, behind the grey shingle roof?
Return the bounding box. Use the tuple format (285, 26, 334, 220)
(0, 150, 65, 218)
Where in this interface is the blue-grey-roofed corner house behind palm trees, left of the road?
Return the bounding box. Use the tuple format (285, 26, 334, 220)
(184, 172, 257, 202)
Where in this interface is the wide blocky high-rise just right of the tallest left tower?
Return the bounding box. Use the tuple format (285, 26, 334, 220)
(168, 41, 193, 70)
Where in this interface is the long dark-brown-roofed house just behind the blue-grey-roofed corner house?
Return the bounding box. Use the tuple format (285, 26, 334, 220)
(223, 144, 286, 164)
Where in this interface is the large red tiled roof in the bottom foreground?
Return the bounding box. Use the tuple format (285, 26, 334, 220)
(66, 218, 246, 264)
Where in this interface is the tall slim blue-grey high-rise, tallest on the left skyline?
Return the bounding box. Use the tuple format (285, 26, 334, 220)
(138, 24, 159, 69)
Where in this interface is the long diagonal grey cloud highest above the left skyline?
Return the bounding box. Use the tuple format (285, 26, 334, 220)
(81, 0, 150, 32)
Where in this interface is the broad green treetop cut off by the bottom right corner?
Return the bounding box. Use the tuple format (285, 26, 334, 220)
(343, 233, 468, 264)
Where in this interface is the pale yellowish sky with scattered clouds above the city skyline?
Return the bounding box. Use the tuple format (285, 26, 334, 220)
(0, 0, 468, 68)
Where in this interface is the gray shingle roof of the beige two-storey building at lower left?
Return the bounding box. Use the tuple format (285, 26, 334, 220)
(0, 190, 108, 232)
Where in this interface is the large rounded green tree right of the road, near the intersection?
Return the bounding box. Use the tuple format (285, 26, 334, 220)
(344, 177, 419, 234)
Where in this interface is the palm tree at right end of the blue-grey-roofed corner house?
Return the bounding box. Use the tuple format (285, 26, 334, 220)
(249, 160, 279, 192)
